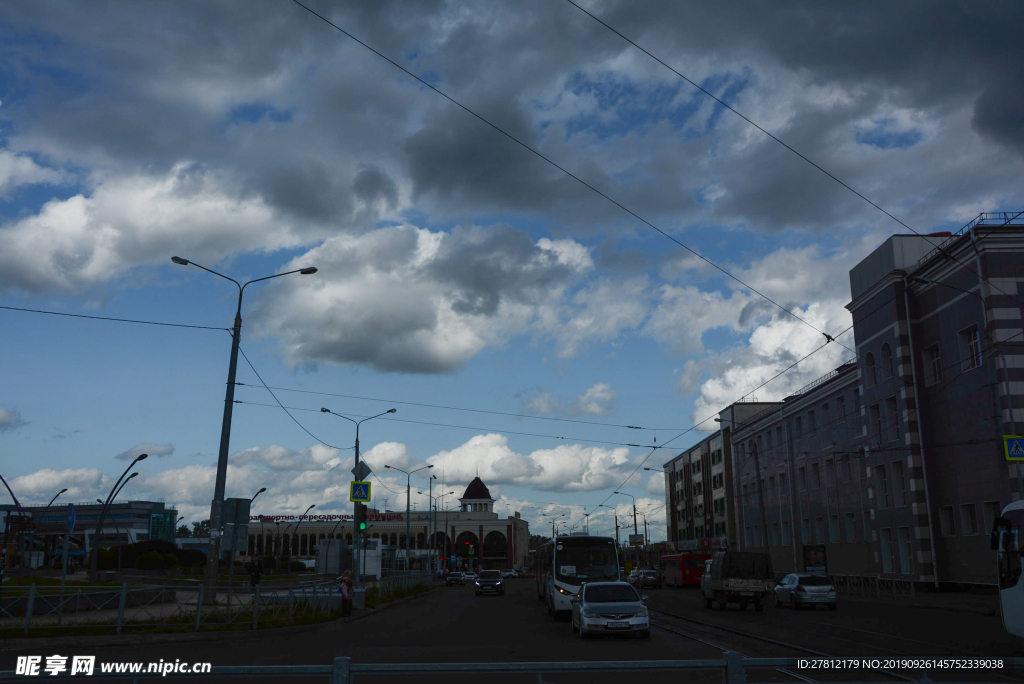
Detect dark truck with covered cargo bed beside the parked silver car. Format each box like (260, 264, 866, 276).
(700, 551, 775, 612)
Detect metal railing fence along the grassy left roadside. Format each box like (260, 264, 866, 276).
(0, 579, 340, 635)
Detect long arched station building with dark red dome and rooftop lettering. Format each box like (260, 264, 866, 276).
(240, 477, 529, 568)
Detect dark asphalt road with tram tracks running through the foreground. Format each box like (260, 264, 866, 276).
(0, 579, 1024, 684)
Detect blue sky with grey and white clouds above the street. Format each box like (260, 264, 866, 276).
(0, 0, 1024, 540)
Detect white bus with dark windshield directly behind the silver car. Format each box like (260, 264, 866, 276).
(537, 536, 622, 619)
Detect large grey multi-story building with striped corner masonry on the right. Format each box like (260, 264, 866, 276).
(696, 214, 1024, 585)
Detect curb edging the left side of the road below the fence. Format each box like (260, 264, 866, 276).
(0, 586, 435, 653)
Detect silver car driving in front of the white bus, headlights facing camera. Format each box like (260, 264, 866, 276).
(572, 582, 650, 639)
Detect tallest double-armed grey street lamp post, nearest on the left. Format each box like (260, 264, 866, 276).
(171, 256, 316, 602)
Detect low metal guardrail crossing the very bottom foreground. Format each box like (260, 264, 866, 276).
(0, 651, 1024, 684)
